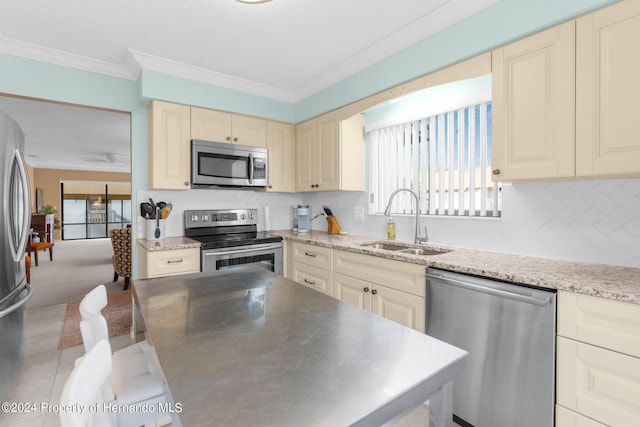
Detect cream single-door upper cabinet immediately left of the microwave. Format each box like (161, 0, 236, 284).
(149, 101, 191, 190)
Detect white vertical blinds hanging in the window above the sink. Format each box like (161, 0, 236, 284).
(368, 102, 501, 216)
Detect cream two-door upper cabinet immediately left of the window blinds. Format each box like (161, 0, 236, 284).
(296, 110, 365, 191)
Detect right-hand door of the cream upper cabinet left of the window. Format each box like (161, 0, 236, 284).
(314, 113, 341, 191)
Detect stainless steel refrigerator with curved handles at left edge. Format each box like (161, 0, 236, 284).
(0, 111, 33, 402)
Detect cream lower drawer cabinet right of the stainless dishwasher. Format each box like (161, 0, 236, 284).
(556, 292, 640, 427)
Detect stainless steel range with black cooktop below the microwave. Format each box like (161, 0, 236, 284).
(184, 209, 282, 275)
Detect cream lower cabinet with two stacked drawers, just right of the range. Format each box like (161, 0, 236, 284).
(291, 242, 333, 295)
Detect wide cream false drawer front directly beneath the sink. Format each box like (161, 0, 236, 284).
(333, 250, 426, 297)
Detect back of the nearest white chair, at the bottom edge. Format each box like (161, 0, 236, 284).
(59, 340, 114, 427)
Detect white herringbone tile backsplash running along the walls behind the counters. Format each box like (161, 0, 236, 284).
(137, 179, 640, 267)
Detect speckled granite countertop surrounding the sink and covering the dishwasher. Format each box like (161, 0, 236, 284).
(274, 230, 640, 304)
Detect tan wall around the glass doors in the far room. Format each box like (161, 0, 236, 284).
(30, 169, 131, 240)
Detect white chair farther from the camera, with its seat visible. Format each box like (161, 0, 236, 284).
(80, 285, 166, 426)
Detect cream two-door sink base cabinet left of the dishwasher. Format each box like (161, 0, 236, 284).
(332, 250, 426, 332)
